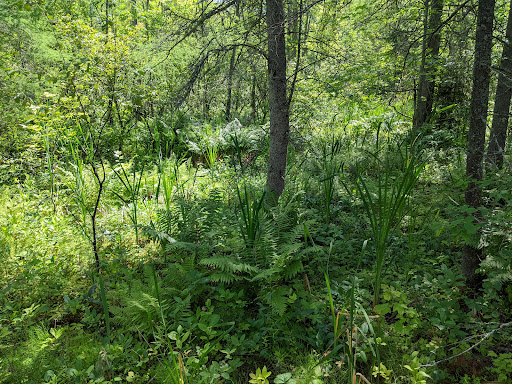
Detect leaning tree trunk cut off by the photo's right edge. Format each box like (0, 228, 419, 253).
(486, 0, 512, 170)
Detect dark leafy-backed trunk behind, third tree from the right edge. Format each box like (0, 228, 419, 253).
(413, 0, 443, 131)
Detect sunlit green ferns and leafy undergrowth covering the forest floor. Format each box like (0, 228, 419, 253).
(0, 112, 512, 383)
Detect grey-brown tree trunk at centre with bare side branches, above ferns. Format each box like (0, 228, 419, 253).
(266, 0, 290, 205)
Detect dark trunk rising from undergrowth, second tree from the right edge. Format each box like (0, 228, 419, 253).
(462, 0, 495, 290)
